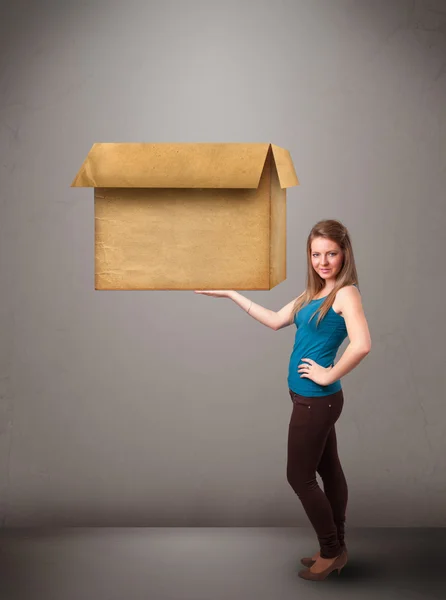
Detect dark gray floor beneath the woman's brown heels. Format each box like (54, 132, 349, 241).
(0, 527, 446, 600)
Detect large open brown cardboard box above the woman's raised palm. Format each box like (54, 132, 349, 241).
(71, 143, 299, 290)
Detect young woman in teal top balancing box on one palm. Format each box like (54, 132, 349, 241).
(195, 220, 371, 580)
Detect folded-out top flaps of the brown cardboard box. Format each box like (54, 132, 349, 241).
(71, 142, 298, 188)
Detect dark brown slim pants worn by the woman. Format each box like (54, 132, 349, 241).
(287, 390, 348, 558)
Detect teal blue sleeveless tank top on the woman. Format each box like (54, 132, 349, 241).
(288, 288, 358, 396)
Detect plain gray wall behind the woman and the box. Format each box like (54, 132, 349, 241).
(0, 0, 446, 526)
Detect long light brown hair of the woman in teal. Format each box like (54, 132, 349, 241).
(292, 219, 359, 327)
